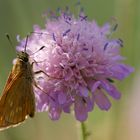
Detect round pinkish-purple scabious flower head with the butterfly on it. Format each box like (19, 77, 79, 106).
(17, 9, 133, 121)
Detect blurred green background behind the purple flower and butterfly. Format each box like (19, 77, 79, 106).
(0, 0, 140, 140)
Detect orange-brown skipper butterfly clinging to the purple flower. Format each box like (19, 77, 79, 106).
(0, 34, 35, 130)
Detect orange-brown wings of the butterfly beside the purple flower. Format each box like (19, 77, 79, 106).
(0, 71, 35, 130)
